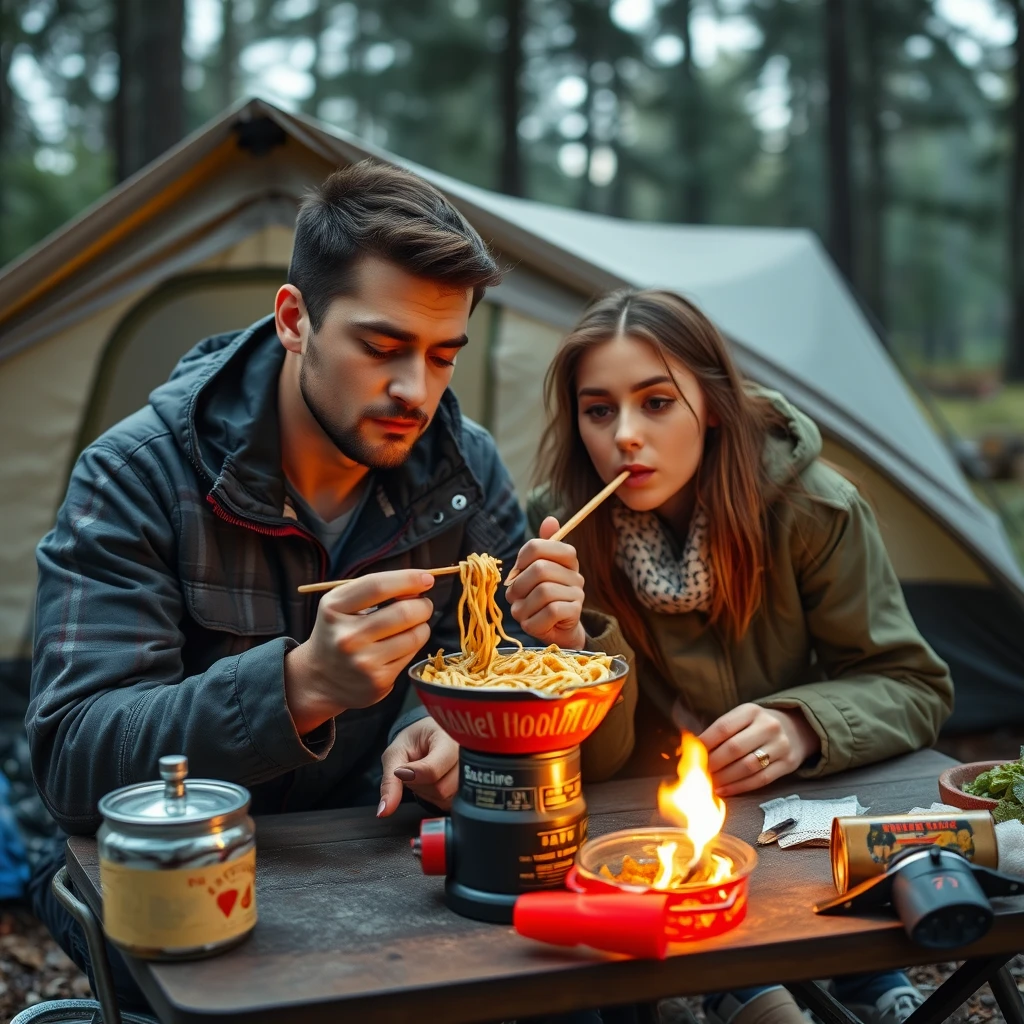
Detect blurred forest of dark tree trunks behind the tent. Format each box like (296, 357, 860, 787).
(0, 0, 1024, 554)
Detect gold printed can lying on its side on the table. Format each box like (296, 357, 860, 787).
(829, 811, 999, 896)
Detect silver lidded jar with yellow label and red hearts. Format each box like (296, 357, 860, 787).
(96, 755, 256, 961)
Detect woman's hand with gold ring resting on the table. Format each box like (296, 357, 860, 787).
(700, 703, 821, 797)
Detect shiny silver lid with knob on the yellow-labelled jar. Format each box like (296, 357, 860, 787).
(99, 754, 249, 828)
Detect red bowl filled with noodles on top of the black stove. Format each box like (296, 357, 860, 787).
(409, 647, 629, 754)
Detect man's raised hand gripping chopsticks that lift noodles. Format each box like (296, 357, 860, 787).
(285, 569, 434, 735)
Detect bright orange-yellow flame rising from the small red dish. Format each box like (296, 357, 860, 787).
(653, 732, 732, 889)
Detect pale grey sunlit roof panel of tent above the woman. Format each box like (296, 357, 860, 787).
(401, 177, 1024, 591)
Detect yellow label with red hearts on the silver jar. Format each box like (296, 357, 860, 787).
(99, 849, 256, 949)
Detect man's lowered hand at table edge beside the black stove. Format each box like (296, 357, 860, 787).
(377, 718, 459, 818)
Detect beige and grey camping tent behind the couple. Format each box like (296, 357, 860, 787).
(0, 100, 1024, 729)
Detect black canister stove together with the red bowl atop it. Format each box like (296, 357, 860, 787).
(410, 648, 629, 924)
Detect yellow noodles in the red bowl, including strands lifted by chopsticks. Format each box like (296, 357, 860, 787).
(423, 554, 611, 694)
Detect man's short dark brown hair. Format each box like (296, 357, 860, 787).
(288, 160, 501, 332)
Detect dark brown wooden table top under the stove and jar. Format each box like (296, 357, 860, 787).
(68, 751, 1024, 1024)
